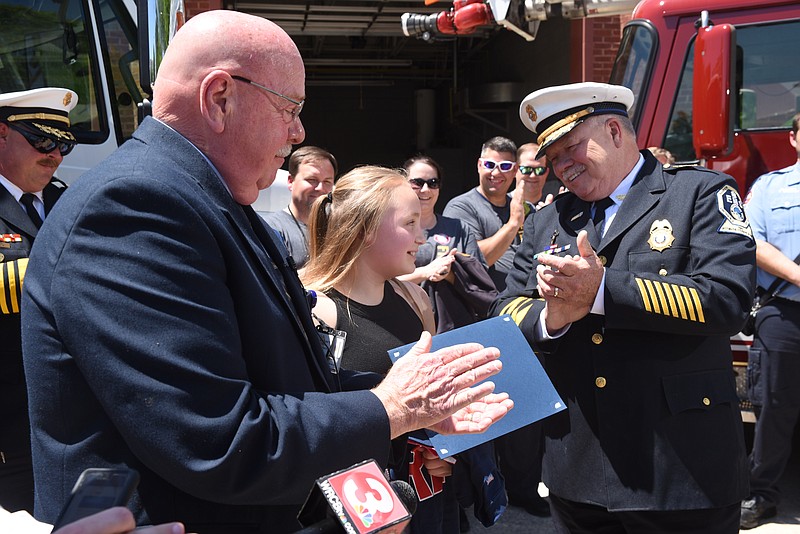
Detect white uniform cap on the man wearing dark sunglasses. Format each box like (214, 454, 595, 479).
(0, 87, 78, 143)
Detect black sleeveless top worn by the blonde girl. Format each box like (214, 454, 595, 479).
(328, 282, 422, 375)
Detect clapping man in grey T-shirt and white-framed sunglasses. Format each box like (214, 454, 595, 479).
(443, 137, 531, 291)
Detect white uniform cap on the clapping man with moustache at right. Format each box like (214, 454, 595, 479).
(519, 82, 633, 159)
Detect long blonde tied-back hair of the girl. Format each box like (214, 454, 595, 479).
(301, 165, 408, 293)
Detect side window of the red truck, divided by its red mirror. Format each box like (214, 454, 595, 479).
(663, 21, 800, 161)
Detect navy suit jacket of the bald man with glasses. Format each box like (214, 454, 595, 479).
(23, 118, 390, 533)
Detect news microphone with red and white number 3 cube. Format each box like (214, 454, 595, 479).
(297, 460, 417, 534)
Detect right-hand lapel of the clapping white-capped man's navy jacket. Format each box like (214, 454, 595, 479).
(597, 156, 666, 252)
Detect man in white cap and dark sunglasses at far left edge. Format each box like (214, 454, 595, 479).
(0, 88, 78, 513)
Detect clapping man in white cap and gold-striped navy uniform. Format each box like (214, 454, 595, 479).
(494, 83, 755, 533)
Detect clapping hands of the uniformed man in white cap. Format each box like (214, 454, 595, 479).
(536, 230, 603, 334)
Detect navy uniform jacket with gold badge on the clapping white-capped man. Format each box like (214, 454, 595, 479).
(494, 151, 755, 511)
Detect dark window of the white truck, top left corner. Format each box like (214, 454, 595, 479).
(0, 0, 108, 143)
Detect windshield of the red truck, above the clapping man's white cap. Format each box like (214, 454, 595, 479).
(610, 23, 656, 129)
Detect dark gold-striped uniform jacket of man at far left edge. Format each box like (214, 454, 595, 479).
(0, 178, 67, 462)
